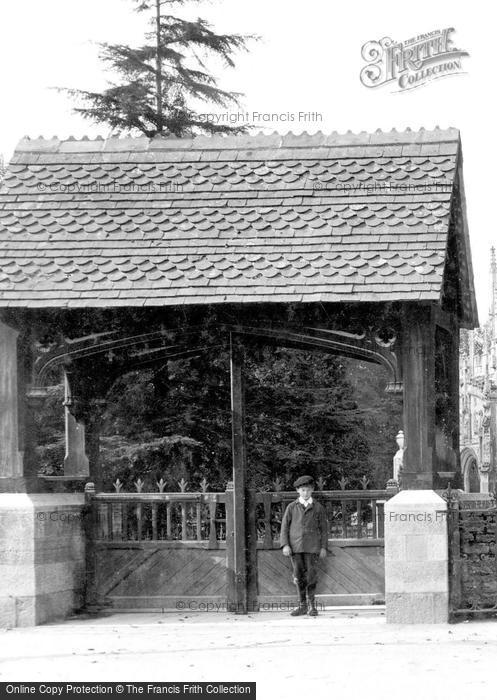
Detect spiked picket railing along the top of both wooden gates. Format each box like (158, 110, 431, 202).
(85, 484, 393, 549)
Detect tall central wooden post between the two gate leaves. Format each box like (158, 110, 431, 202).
(230, 333, 247, 614)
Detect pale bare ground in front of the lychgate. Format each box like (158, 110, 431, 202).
(0, 609, 497, 700)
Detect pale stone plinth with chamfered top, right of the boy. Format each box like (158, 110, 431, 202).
(385, 490, 449, 623)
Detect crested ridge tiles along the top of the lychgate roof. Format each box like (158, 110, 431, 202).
(15, 126, 459, 153)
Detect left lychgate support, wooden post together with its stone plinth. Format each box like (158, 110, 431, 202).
(0, 321, 85, 628)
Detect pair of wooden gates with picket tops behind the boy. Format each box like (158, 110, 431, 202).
(86, 484, 391, 611)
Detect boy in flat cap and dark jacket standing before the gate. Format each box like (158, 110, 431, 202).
(280, 475, 328, 617)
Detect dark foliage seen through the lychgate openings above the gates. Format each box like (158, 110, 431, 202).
(34, 347, 400, 490)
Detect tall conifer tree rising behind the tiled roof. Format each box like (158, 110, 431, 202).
(62, 0, 256, 137)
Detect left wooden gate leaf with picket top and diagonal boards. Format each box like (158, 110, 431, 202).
(87, 492, 232, 610)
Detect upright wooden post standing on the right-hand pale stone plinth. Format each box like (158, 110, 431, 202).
(402, 306, 435, 489)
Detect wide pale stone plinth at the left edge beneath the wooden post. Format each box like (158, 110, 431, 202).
(0, 493, 85, 627)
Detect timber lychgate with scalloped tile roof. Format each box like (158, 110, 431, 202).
(0, 129, 477, 625)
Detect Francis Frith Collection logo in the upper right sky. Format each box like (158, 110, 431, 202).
(360, 27, 469, 92)
